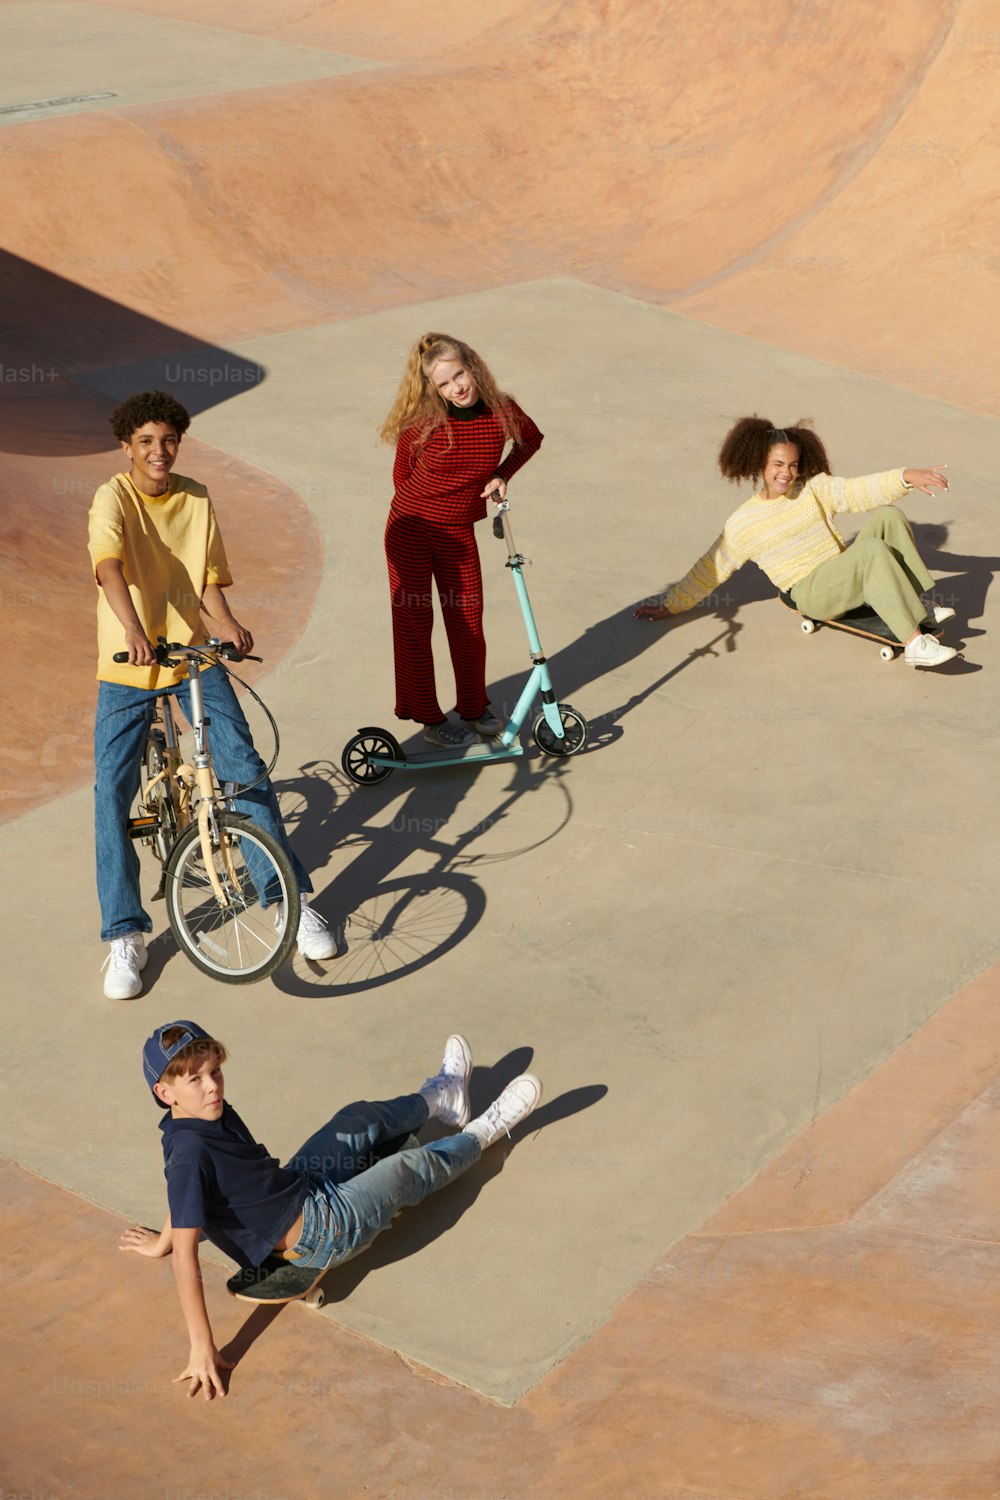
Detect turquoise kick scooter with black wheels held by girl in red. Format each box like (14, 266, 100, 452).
(340, 500, 588, 786)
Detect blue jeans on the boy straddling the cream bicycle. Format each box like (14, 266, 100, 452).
(94, 666, 312, 942)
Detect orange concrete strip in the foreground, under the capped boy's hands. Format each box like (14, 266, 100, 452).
(7, 971, 1000, 1500)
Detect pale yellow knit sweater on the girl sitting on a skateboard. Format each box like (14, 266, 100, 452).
(663, 470, 910, 615)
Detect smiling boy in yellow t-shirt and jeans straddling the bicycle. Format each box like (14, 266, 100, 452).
(88, 390, 337, 1001)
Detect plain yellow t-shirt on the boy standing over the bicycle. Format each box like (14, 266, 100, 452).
(87, 474, 232, 689)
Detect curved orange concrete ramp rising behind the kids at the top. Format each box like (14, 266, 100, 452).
(0, 0, 1000, 411)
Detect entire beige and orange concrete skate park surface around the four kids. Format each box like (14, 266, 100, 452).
(0, 0, 1000, 1500)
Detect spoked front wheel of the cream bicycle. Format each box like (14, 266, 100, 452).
(166, 813, 300, 984)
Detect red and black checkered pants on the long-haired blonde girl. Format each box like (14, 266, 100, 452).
(385, 510, 489, 725)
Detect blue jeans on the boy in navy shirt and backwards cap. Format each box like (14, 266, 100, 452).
(285, 1094, 483, 1266)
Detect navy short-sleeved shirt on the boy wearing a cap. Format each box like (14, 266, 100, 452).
(160, 1104, 306, 1266)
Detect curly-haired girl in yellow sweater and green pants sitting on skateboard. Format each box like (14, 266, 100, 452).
(636, 417, 957, 666)
